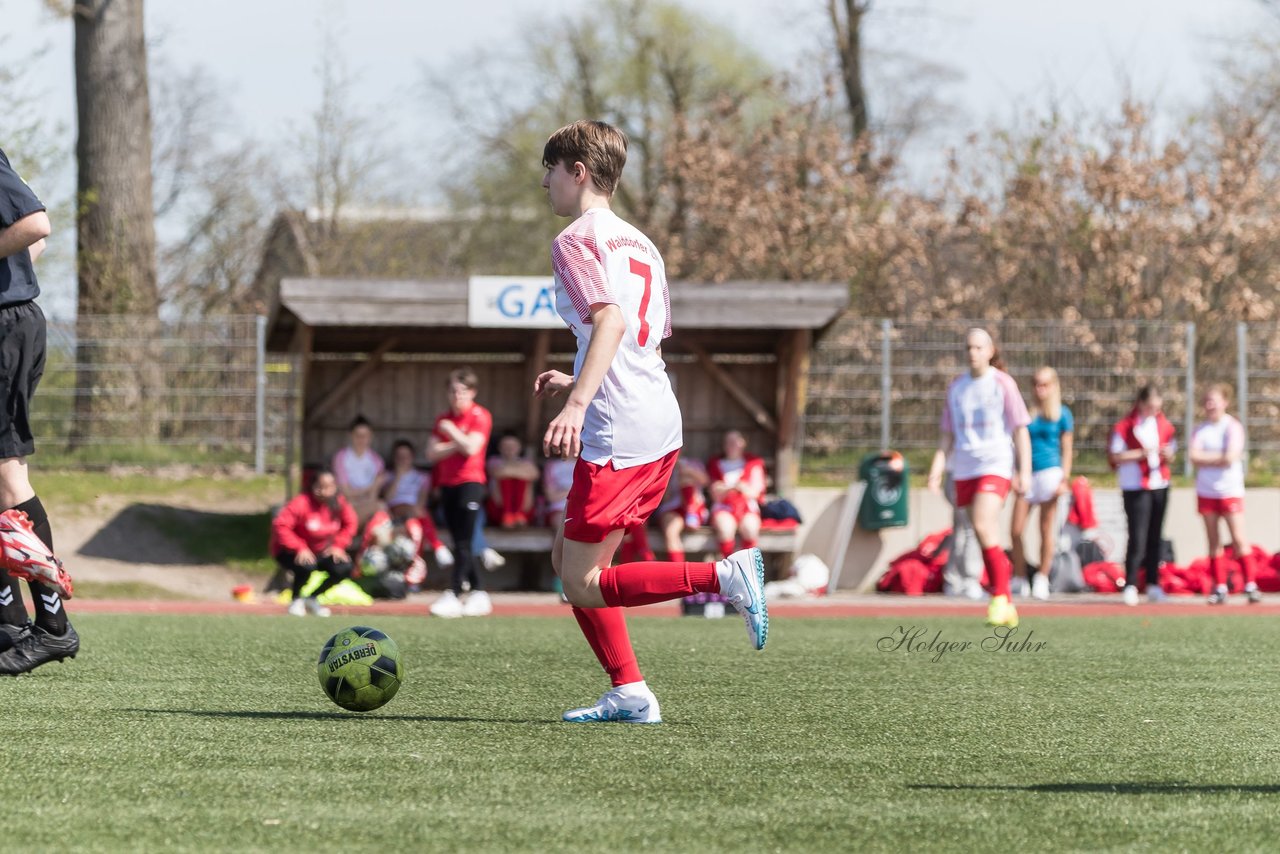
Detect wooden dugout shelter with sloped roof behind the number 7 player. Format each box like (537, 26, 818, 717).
(268, 277, 849, 494)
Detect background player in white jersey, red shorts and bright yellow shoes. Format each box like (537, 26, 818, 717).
(929, 329, 1032, 629)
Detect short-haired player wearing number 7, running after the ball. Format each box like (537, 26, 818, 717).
(534, 122, 769, 723)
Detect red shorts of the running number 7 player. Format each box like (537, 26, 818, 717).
(564, 449, 680, 543)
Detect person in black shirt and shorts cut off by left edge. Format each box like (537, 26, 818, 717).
(0, 151, 79, 676)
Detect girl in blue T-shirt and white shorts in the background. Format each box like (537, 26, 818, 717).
(1011, 367, 1075, 599)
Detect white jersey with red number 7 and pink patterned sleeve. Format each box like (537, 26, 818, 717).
(552, 209, 682, 469)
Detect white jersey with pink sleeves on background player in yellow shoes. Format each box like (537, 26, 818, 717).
(942, 367, 1030, 480)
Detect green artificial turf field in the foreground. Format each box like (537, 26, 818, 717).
(0, 613, 1280, 853)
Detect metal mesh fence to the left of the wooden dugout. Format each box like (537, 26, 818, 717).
(32, 316, 297, 472)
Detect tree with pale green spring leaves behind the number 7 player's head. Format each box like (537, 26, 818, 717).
(429, 0, 781, 273)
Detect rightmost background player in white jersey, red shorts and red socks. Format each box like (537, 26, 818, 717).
(1189, 385, 1262, 604)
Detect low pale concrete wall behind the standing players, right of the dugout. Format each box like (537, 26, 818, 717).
(794, 488, 1280, 589)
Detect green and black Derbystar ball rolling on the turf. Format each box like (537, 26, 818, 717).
(319, 626, 404, 712)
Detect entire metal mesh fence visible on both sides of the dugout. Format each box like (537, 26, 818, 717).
(32, 316, 1280, 478)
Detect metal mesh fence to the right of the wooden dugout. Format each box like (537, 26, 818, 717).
(804, 319, 1213, 478)
